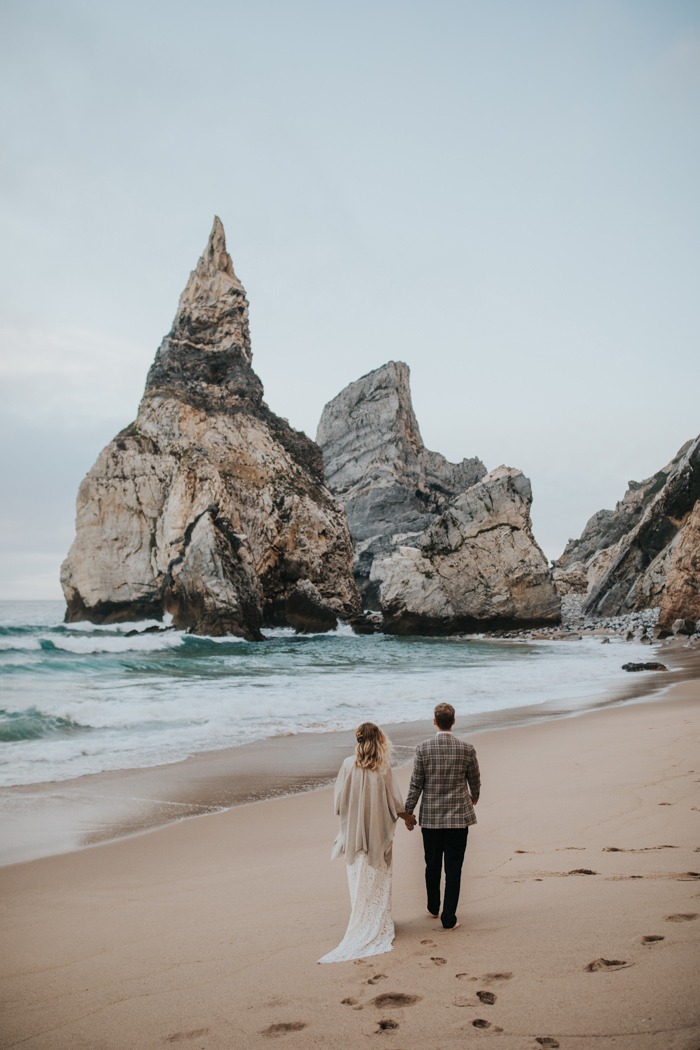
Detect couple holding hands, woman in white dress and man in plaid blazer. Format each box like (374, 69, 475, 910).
(319, 704, 481, 963)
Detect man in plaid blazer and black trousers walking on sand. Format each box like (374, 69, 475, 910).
(405, 704, 481, 929)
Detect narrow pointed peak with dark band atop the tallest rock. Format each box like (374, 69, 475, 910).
(146, 215, 262, 404)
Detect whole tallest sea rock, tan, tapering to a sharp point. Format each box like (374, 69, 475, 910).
(61, 218, 360, 639)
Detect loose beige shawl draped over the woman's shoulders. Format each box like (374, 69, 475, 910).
(331, 755, 403, 867)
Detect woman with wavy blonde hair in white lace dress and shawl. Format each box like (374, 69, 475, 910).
(319, 722, 412, 963)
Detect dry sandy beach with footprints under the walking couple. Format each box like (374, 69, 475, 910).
(0, 651, 700, 1050)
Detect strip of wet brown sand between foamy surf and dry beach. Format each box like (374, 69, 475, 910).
(0, 642, 700, 868)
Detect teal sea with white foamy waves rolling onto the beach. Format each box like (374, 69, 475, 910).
(0, 601, 650, 786)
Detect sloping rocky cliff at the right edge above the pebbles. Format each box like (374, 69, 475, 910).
(555, 437, 700, 629)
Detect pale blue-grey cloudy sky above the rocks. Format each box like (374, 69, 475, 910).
(0, 0, 700, 599)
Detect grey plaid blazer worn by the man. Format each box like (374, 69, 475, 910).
(406, 732, 481, 827)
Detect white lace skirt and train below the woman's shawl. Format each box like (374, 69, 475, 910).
(319, 853, 394, 963)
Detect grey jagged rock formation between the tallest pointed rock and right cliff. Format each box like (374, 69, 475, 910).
(317, 361, 559, 634)
